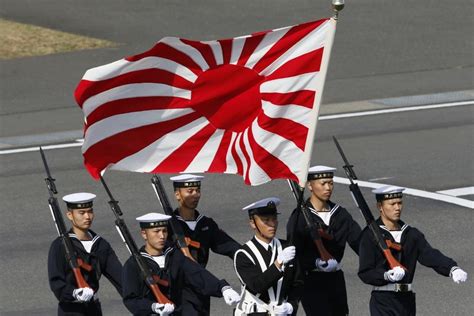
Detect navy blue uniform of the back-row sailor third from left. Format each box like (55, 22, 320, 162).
(169, 209, 240, 315)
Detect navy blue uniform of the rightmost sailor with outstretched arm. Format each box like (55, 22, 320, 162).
(359, 218, 457, 315)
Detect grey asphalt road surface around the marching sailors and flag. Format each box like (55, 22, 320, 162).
(0, 0, 474, 315)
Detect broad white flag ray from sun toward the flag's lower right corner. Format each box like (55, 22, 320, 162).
(252, 120, 306, 178)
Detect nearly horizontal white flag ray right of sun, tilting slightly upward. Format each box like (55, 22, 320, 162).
(260, 72, 319, 93)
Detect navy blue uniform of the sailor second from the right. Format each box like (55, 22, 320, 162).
(286, 199, 361, 316)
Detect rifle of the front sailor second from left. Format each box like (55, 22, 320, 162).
(100, 176, 173, 304)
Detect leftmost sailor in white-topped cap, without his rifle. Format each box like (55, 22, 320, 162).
(48, 193, 122, 315)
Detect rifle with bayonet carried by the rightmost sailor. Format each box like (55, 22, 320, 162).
(332, 136, 406, 270)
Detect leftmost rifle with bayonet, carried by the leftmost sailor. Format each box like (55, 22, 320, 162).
(40, 147, 92, 288)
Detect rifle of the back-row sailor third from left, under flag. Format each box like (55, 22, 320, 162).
(151, 174, 201, 262)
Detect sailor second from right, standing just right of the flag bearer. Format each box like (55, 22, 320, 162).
(287, 165, 361, 316)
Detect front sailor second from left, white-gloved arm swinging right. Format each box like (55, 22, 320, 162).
(122, 213, 240, 316)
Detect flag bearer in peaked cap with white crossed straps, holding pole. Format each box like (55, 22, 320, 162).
(234, 198, 302, 315)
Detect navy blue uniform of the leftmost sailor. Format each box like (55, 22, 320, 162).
(48, 230, 122, 315)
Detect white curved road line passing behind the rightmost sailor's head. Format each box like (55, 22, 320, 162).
(333, 177, 474, 209)
